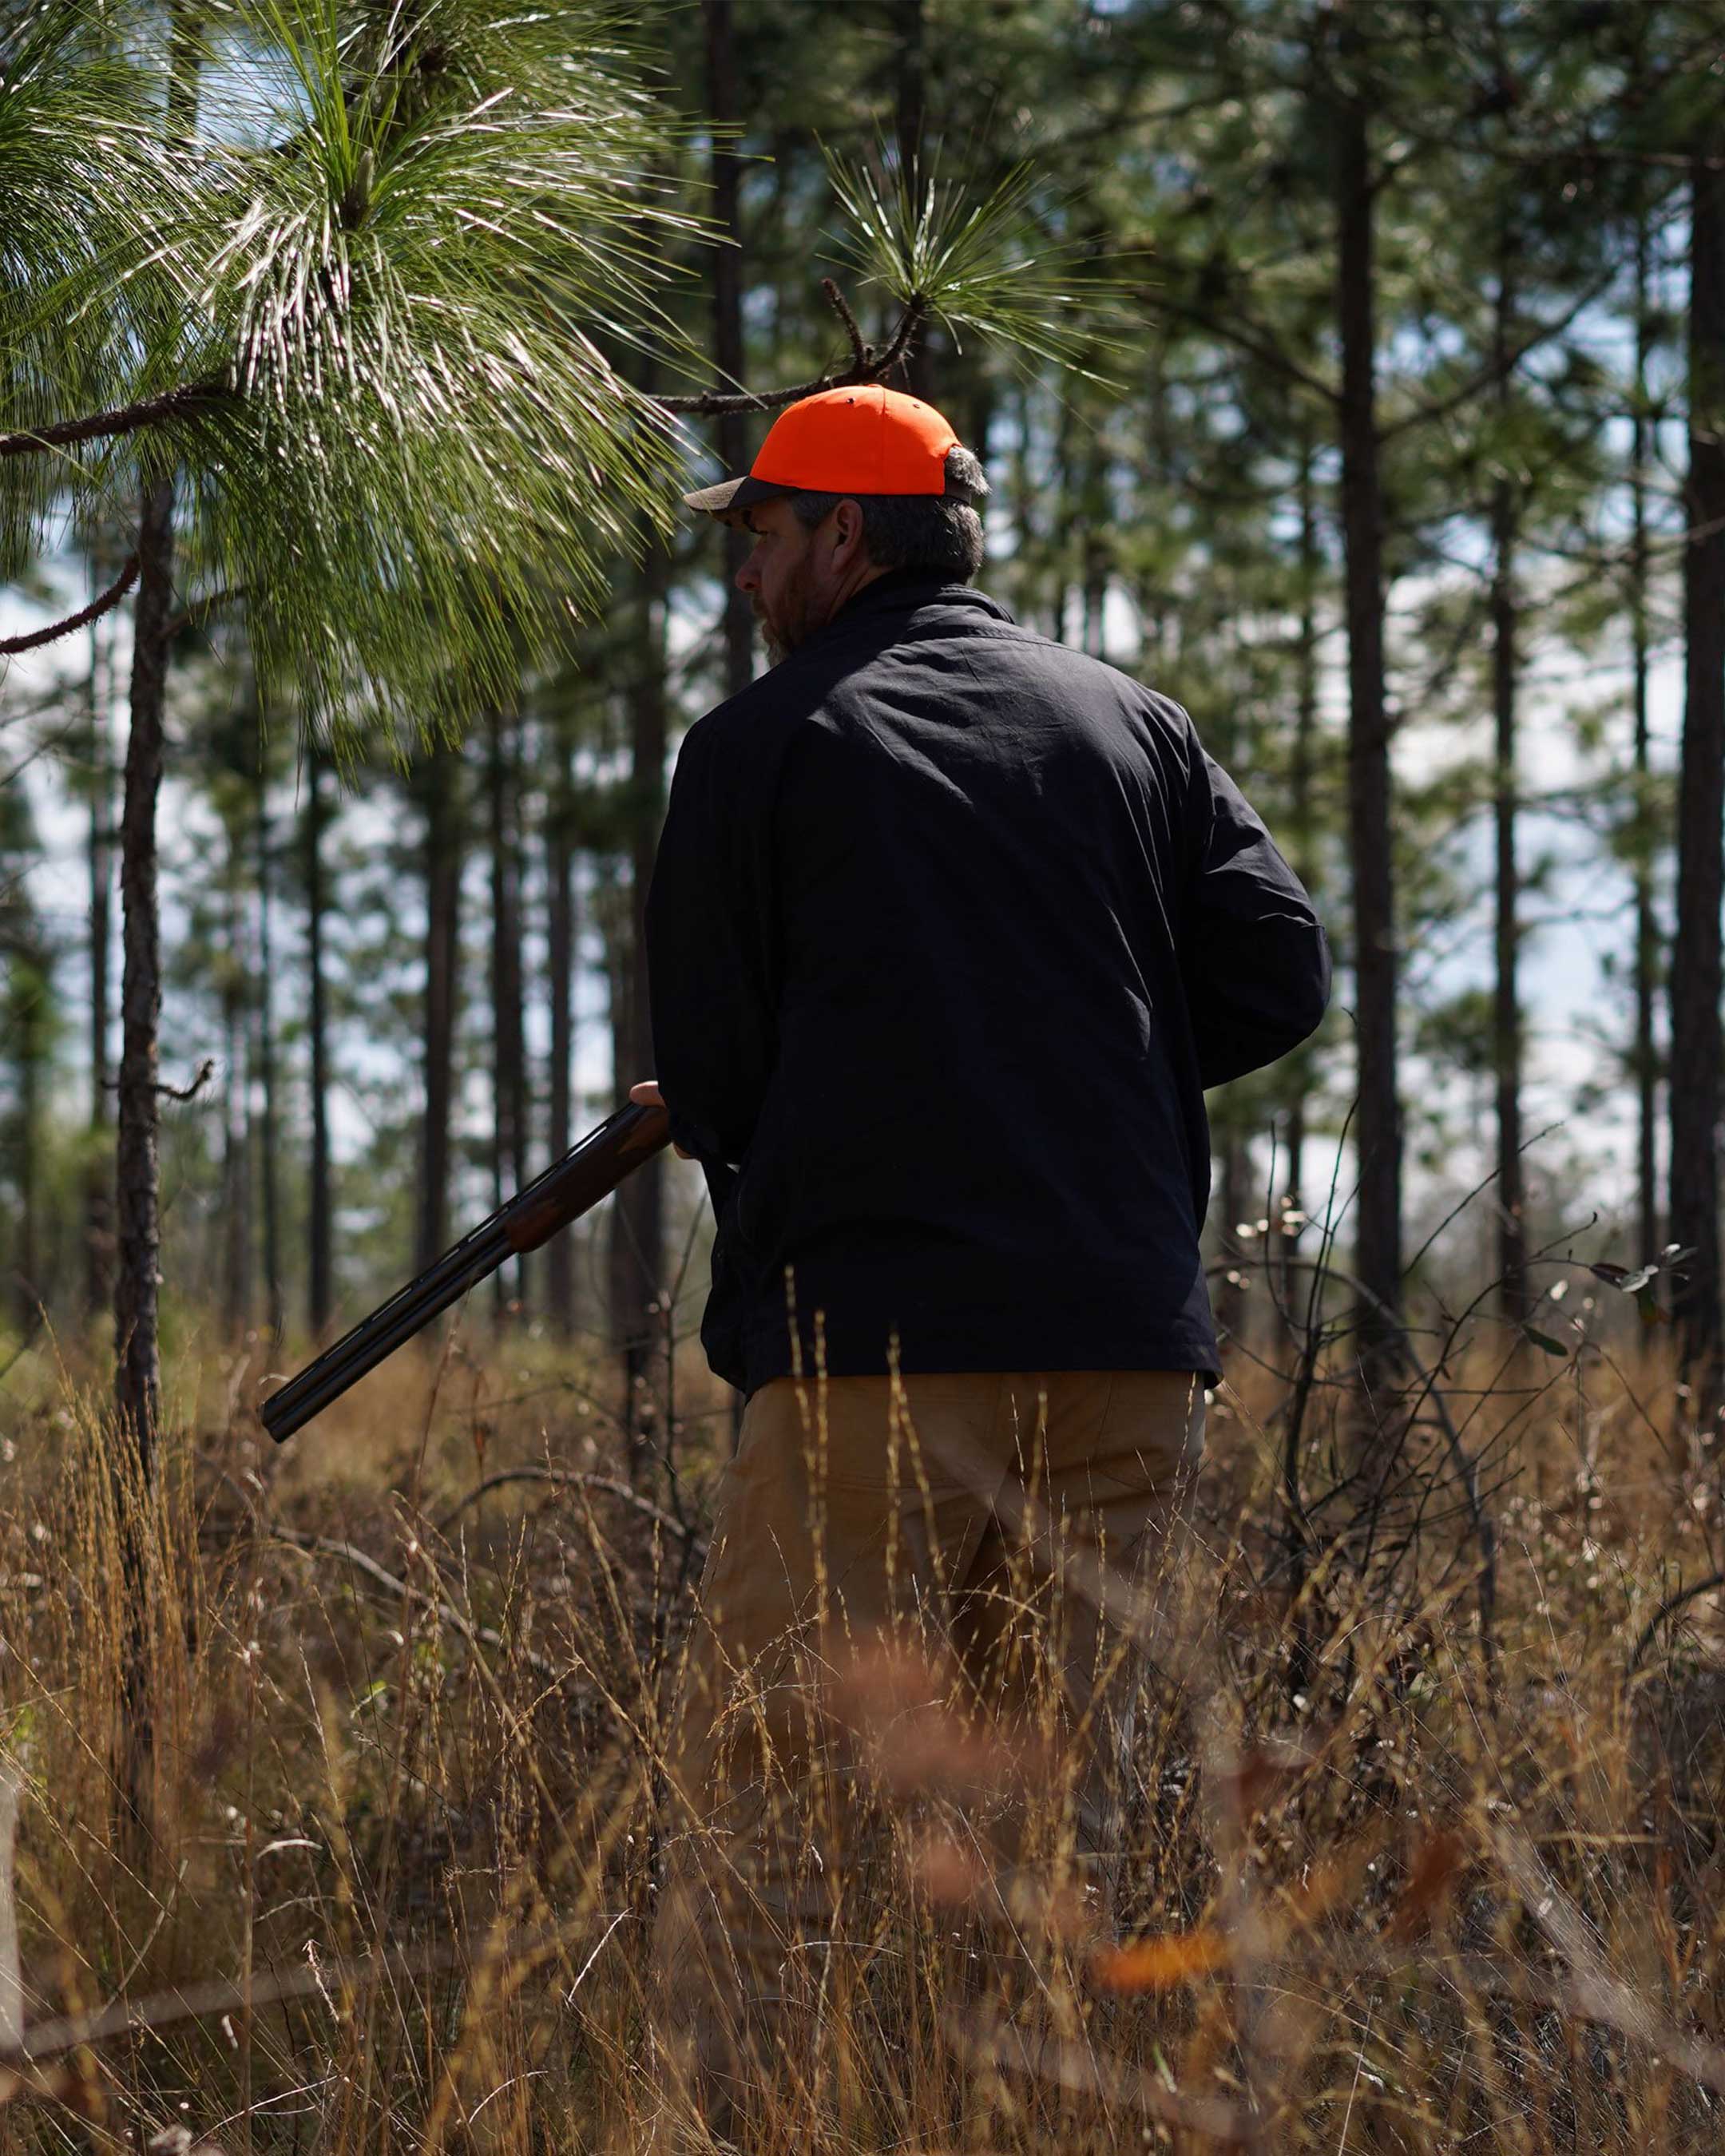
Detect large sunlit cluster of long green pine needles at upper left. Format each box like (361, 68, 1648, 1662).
(0, 0, 694, 731)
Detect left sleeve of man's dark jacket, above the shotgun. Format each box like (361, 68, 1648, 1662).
(647, 720, 779, 1197)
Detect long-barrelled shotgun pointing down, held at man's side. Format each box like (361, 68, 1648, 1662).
(261, 1102, 671, 1445)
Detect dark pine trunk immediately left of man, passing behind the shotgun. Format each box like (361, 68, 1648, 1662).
(610, 545, 668, 1475)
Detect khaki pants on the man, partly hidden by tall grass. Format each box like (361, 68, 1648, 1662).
(653, 1371, 1204, 2113)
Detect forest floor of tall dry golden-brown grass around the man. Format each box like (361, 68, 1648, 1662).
(0, 1341, 1725, 2156)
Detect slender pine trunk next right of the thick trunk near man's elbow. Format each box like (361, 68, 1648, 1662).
(1490, 240, 1527, 1324)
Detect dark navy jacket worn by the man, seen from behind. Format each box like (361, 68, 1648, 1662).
(647, 572, 1330, 1391)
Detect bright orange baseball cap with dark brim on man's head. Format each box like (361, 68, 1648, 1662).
(684, 382, 958, 517)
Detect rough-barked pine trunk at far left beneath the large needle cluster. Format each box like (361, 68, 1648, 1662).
(114, 477, 175, 1488)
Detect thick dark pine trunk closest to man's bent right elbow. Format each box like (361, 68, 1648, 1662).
(1330, 95, 1402, 1371)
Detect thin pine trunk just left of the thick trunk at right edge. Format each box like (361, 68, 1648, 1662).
(1630, 218, 1660, 1266)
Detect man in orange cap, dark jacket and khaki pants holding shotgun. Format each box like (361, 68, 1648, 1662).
(636, 386, 1328, 2121)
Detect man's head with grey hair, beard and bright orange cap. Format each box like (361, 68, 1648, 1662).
(686, 386, 988, 660)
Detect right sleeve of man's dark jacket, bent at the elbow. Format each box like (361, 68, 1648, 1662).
(1180, 739, 1330, 1087)
